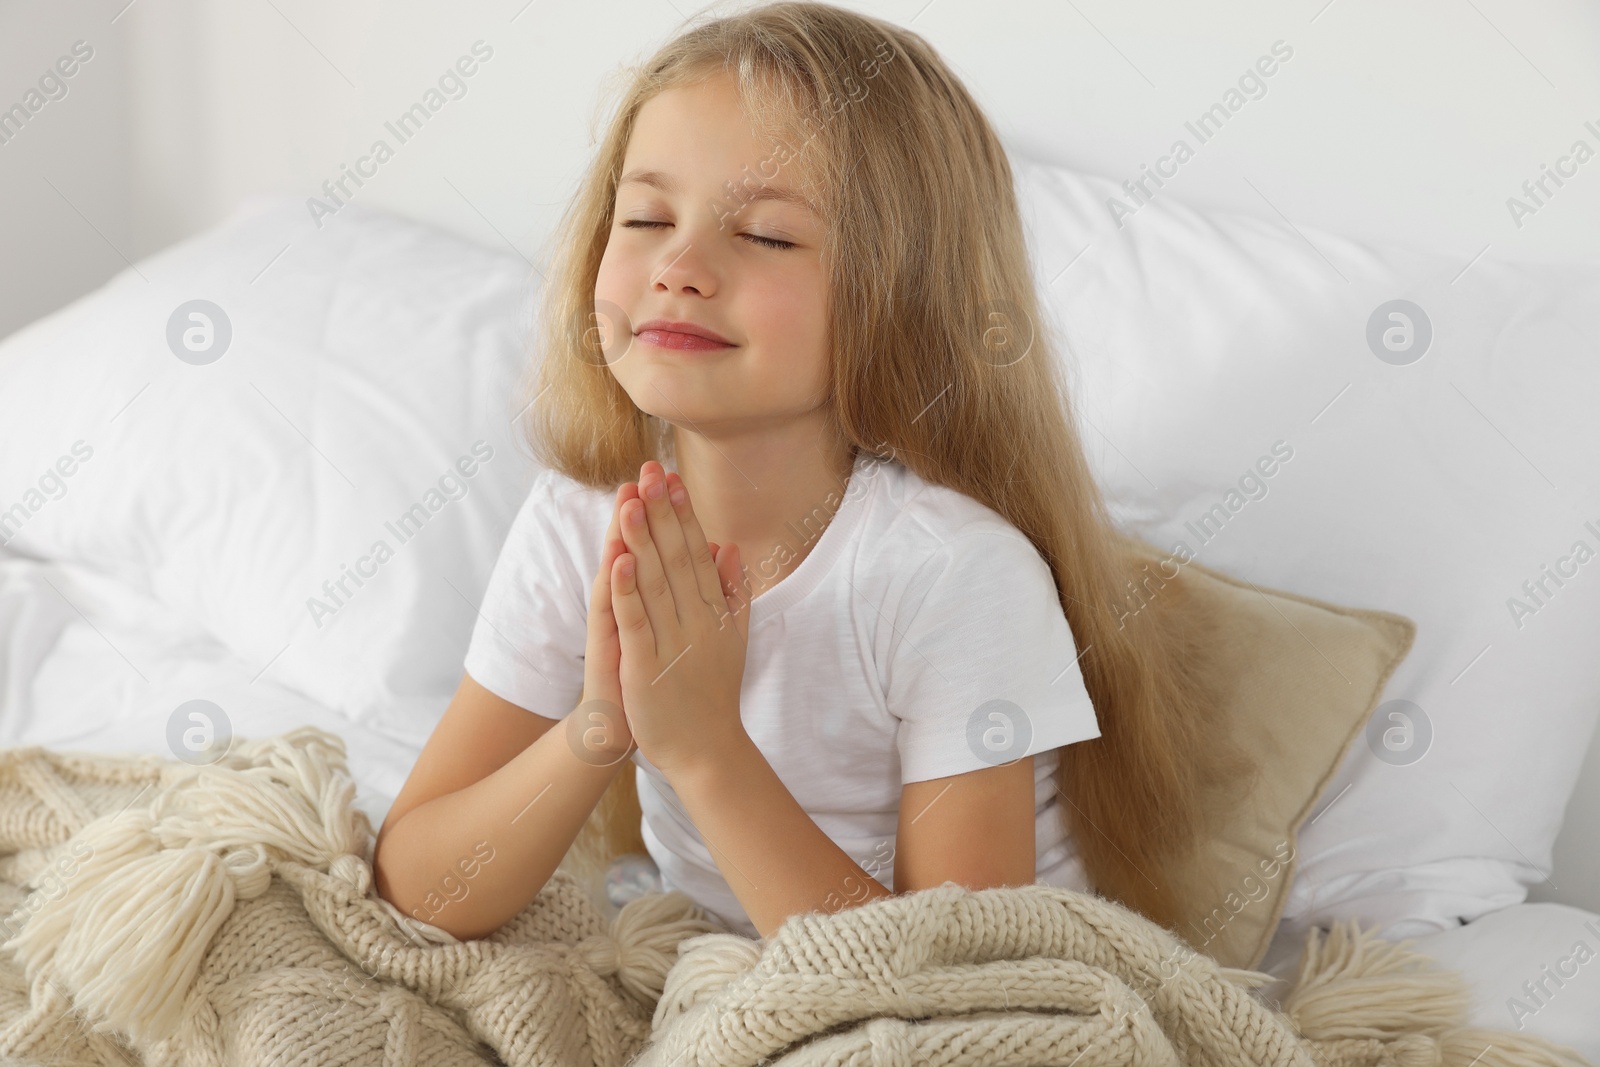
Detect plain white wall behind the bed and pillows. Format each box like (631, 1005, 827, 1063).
(0, 0, 1600, 907)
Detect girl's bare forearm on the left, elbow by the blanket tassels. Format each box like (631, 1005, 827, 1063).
(373, 721, 632, 939)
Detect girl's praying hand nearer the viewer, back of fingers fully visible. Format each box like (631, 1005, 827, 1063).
(611, 459, 750, 777)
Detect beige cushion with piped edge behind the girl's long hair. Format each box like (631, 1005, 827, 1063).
(1152, 550, 1416, 968)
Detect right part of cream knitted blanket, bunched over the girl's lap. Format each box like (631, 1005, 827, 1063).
(635, 883, 1592, 1067)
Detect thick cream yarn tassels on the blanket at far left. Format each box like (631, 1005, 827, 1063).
(5, 726, 371, 1043)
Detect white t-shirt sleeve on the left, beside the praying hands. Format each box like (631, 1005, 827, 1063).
(464, 470, 589, 718)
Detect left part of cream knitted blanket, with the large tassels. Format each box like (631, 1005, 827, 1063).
(0, 728, 720, 1067)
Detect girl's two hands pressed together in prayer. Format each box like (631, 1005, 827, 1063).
(574, 459, 750, 777)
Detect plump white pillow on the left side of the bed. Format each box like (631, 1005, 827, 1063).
(0, 197, 538, 744)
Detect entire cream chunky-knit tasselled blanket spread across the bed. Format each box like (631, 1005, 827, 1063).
(0, 728, 1584, 1067)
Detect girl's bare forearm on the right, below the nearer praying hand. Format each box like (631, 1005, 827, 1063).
(670, 739, 893, 937)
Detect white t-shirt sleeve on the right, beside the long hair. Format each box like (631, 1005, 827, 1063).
(886, 528, 1099, 784)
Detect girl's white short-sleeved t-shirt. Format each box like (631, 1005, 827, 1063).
(466, 453, 1099, 937)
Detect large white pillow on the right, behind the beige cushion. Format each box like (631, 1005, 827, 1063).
(1013, 154, 1600, 936)
